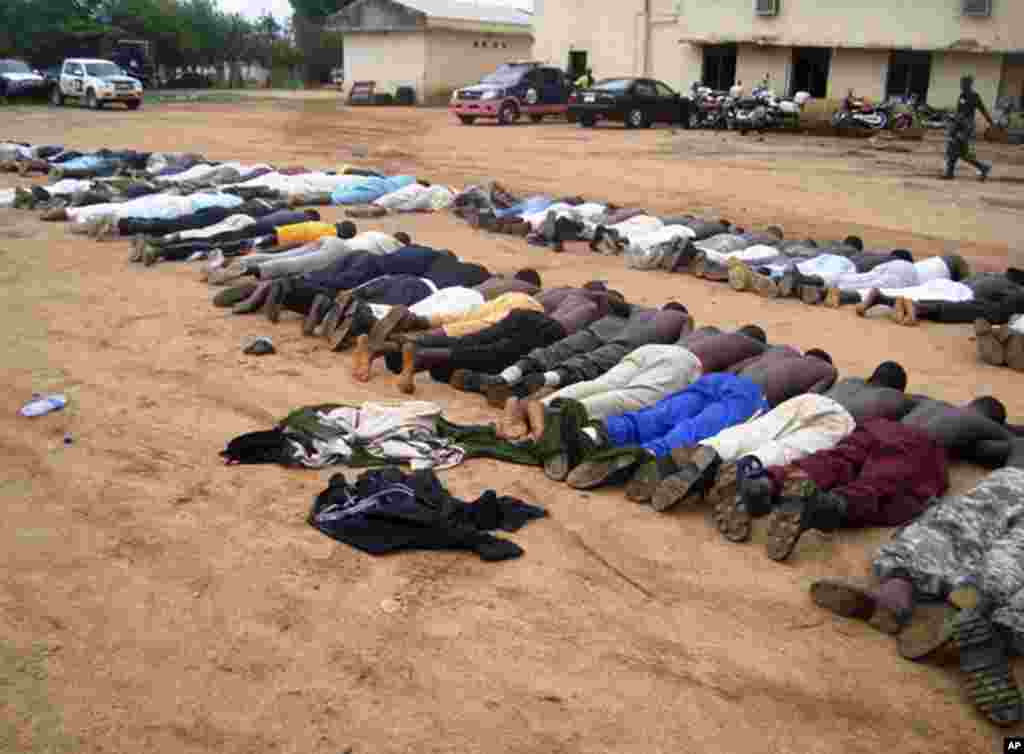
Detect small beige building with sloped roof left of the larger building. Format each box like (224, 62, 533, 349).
(328, 0, 534, 104)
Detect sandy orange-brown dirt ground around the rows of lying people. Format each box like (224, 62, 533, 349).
(0, 102, 1024, 754)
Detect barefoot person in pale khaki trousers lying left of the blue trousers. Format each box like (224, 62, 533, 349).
(495, 325, 767, 439)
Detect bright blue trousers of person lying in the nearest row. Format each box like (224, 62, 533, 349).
(605, 374, 768, 456)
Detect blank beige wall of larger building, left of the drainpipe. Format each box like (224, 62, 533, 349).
(534, 0, 643, 76)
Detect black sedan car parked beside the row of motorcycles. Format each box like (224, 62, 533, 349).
(569, 78, 693, 128)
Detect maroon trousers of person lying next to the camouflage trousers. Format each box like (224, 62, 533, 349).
(768, 419, 949, 528)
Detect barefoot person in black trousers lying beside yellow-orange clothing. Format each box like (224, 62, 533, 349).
(353, 284, 627, 392)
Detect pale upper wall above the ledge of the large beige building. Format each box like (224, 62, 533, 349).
(671, 0, 1024, 51)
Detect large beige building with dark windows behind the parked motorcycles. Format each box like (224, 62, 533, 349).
(534, 0, 1024, 107)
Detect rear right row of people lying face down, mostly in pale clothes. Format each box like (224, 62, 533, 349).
(455, 195, 1024, 325)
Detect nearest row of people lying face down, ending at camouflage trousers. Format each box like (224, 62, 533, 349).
(192, 231, 1024, 724)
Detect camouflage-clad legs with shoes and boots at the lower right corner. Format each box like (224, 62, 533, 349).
(811, 439, 1024, 726)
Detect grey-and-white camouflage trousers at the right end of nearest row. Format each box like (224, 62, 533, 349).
(873, 468, 1024, 638)
